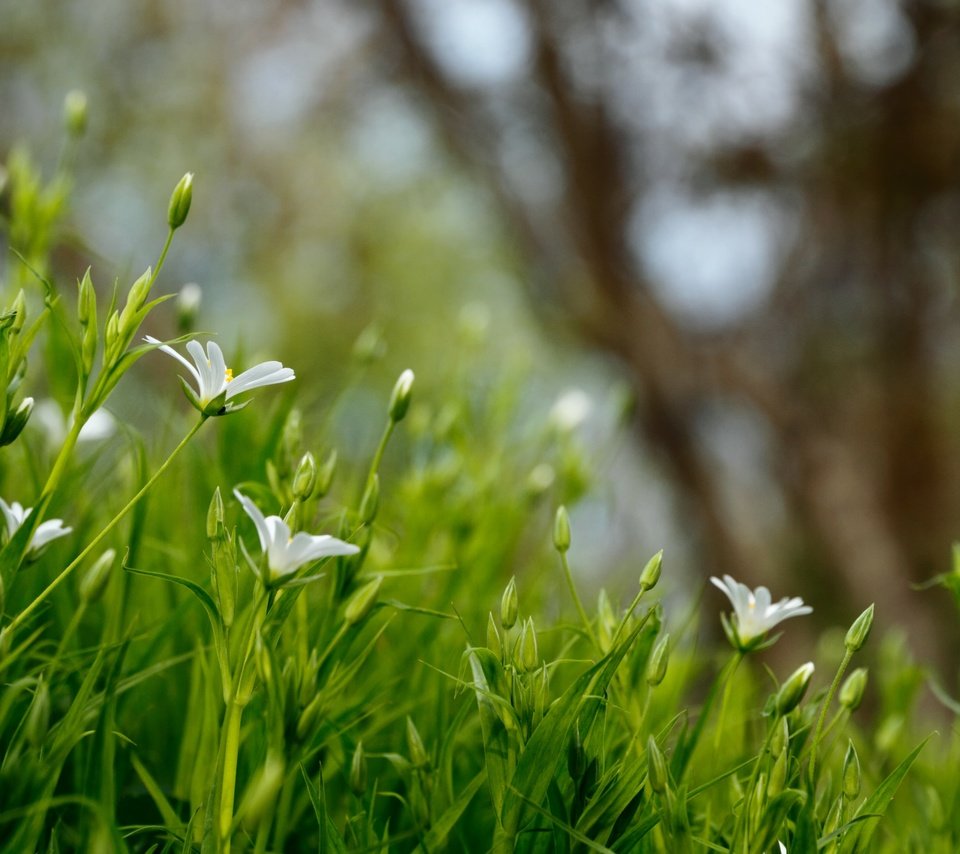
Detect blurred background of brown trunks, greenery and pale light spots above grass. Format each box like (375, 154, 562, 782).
(0, 0, 960, 666)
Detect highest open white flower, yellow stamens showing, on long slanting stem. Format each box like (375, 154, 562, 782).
(144, 335, 295, 415)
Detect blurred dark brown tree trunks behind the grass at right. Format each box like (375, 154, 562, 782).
(381, 0, 960, 664)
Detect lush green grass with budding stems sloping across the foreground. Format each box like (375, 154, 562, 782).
(0, 112, 960, 854)
